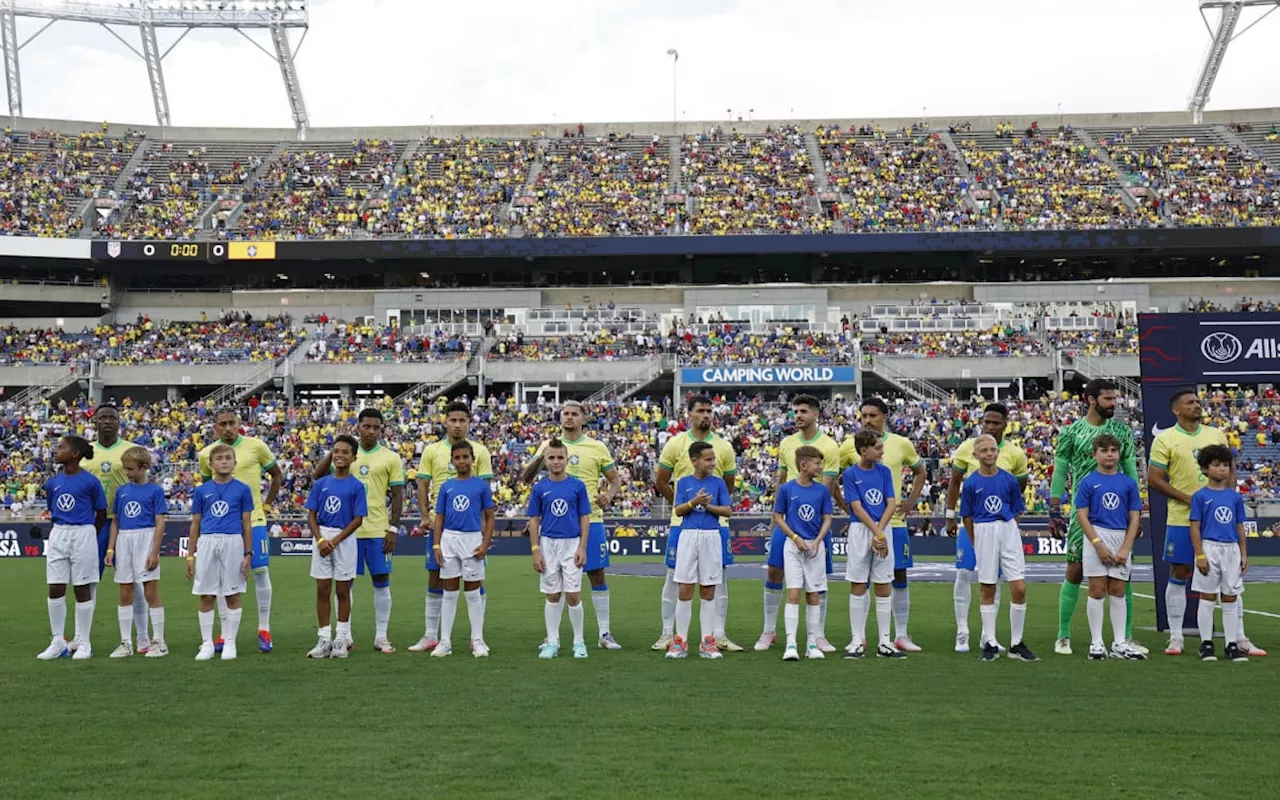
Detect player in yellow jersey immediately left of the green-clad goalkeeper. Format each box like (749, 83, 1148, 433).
(946, 403, 1030, 653)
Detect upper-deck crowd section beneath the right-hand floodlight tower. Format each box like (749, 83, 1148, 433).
(1098, 125, 1280, 227)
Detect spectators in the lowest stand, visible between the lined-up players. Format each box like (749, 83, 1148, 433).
(0, 390, 1280, 518)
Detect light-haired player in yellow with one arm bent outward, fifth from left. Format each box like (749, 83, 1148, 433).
(520, 401, 622, 650)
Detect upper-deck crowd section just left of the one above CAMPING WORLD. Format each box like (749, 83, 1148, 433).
(524, 136, 678, 236)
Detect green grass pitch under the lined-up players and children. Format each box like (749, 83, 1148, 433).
(0, 557, 1280, 797)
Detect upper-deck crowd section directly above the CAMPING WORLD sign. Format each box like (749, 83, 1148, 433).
(681, 125, 831, 234)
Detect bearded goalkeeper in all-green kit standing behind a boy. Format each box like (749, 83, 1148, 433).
(1048, 378, 1147, 655)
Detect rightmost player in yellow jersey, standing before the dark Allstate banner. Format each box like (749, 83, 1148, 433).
(1147, 389, 1266, 657)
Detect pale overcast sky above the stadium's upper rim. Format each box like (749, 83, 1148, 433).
(18, 0, 1280, 127)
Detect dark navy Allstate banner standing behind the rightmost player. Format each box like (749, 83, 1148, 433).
(1138, 312, 1280, 631)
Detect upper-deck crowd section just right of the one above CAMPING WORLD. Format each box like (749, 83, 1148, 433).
(815, 125, 982, 233)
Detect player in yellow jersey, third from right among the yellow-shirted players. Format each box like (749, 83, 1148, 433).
(836, 397, 927, 653)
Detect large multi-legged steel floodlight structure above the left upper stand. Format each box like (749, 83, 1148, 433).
(0, 0, 309, 140)
